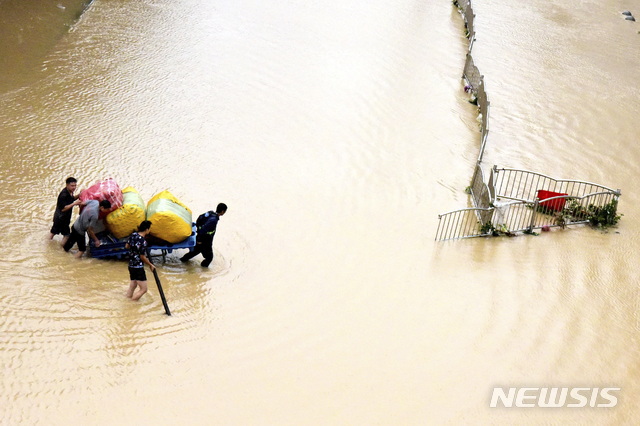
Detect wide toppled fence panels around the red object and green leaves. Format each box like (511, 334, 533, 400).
(436, 165, 620, 241)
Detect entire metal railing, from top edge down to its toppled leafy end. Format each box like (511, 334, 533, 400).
(436, 0, 620, 241)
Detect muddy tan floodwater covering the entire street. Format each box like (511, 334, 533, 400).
(0, 0, 640, 426)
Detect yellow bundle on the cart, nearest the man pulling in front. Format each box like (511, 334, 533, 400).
(147, 191, 191, 243)
